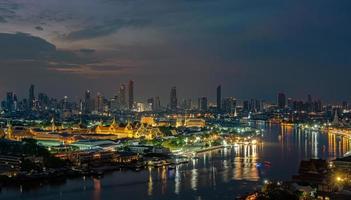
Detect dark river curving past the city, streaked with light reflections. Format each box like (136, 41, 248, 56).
(0, 123, 350, 200)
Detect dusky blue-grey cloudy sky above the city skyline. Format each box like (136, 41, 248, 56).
(0, 0, 351, 102)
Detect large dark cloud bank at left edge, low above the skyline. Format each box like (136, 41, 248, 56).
(0, 33, 133, 77)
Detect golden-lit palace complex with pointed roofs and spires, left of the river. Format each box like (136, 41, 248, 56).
(0, 119, 164, 144)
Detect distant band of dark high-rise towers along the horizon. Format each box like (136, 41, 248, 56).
(0, 80, 348, 106)
